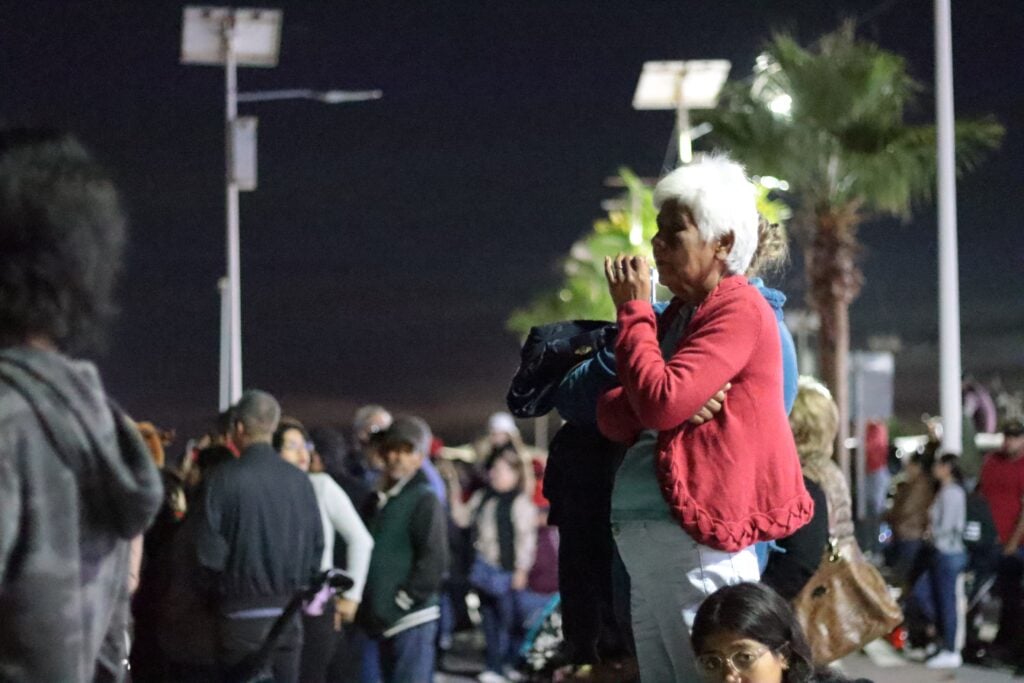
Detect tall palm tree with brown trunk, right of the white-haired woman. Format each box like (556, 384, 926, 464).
(700, 24, 1002, 475)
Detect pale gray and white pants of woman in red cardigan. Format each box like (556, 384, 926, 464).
(612, 519, 761, 683)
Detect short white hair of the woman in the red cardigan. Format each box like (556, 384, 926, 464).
(654, 156, 758, 274)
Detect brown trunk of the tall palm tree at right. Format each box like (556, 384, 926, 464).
(805, 203, 863, 481)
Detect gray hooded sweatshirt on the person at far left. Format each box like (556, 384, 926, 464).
(0, 347, 163, 682)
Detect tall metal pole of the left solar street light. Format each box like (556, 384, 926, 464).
(224, 16, 242, 403)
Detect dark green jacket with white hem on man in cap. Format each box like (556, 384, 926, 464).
(359, 470, 447, 637)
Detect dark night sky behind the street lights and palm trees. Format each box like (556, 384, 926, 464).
(0, 0, 1024, 440)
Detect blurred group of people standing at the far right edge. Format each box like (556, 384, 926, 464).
(882, 413, 1024, 669)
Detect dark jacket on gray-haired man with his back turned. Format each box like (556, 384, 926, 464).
(197, 443, 324, 614)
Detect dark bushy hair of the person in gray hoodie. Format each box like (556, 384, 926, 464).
(0, 128, 126, 352)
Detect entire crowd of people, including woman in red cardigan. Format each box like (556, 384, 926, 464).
(0, 129, 1024, 683)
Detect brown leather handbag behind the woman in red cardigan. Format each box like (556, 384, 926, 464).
(793, 539, 903, 666)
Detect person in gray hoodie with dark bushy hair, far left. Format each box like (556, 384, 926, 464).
(0, 129, 163, 683)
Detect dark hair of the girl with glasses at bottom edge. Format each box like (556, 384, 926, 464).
(690, 584, 814, 683)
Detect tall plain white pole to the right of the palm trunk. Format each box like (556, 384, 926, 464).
(935, 0, 964, 454)
